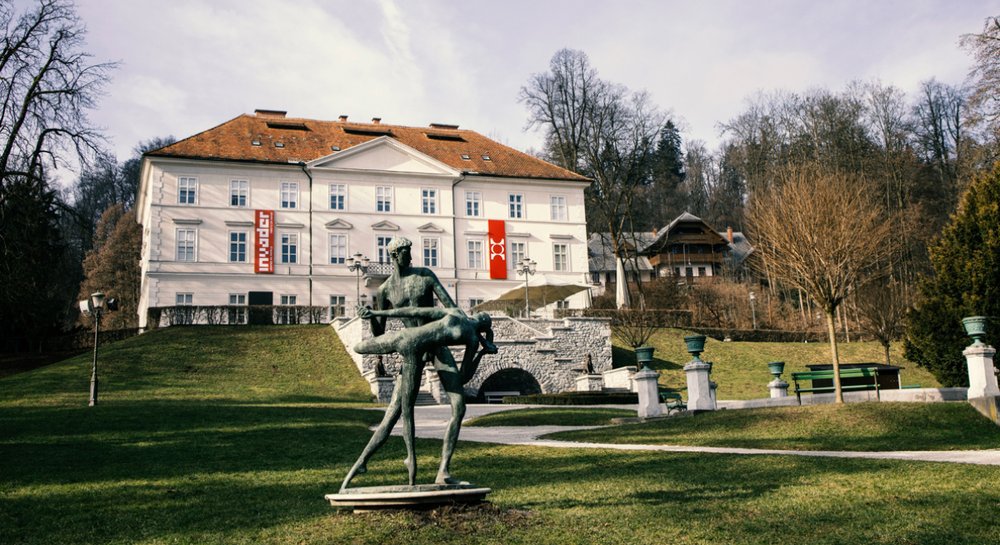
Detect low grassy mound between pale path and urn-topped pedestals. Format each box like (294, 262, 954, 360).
(552, 402, 1000, 451)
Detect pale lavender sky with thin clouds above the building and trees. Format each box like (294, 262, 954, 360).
(64, 0, 1000, 166)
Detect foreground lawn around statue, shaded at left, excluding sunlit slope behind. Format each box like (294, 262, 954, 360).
(0, 401, 1000, 544)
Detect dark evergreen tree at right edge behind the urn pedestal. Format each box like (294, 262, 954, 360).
(905, 159, 1000, 386)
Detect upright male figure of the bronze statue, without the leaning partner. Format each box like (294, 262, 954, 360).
(341, 237, 478, 490)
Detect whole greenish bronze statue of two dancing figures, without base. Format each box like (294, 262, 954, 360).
(341, 237, 496, 491)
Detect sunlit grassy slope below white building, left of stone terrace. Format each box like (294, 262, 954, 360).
(0, 326, 370, 405)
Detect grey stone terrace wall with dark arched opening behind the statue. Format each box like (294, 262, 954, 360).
(332, 316, 611, 401)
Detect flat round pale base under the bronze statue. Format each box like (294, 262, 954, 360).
(324, 484, 491, 513)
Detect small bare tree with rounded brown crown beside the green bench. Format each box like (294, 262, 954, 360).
(748, 165, 894, 403)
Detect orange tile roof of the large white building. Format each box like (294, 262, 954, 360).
(146, 114, 590, 182)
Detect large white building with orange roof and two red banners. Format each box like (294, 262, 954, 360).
(137, 110, 589, 327)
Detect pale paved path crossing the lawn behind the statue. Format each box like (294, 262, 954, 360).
(393, 405, 1000, 465)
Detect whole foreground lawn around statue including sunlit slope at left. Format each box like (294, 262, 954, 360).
(0, 326, 1000, 545)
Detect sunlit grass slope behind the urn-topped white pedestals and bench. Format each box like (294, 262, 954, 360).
(614, 329, 940, 399)
